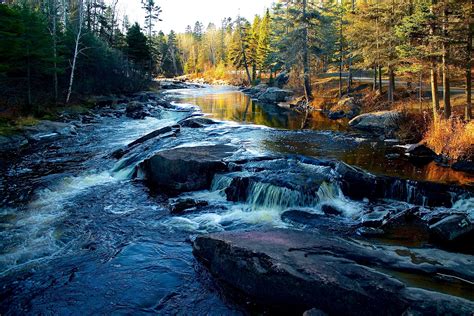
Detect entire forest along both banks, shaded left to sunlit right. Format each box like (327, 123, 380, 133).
(0, 0, 473, 160)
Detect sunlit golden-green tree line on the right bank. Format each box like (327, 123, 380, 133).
(178, 0, 474, 120)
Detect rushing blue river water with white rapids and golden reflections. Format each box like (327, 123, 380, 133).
(0, 87, 473, 315)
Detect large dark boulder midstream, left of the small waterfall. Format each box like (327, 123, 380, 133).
(140, 145, 237, 192)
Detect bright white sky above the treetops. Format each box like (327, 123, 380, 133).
(115, 0, 273, 33)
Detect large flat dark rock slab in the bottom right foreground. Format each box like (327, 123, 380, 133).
(194, 230, 474, 315)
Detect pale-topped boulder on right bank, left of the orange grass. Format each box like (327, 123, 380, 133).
(349, 111, 402, 137)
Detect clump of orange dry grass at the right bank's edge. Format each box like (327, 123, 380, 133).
(425, 118, 474, 160)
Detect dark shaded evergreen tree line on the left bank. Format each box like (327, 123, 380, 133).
(0, 0, 169, 113)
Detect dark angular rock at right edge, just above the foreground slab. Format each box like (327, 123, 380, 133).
(429, 215, 474, 241)
